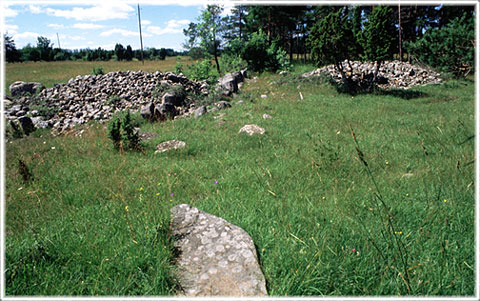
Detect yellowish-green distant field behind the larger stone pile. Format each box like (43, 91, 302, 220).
(5, 57, 192, 95)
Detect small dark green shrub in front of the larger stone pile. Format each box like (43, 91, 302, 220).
(107, 111, 141, 150)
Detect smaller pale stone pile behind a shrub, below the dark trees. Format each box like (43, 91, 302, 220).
(303, 60, 442, 89)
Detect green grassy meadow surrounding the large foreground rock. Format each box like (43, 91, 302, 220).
(5, 61, 475, 296)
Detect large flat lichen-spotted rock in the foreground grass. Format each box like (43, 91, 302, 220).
(171, 204, 267, 297)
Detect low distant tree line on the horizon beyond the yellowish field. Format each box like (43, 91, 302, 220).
(4, 34, 184, 63)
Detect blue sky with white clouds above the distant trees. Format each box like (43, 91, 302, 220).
(2, 0, 231, 50)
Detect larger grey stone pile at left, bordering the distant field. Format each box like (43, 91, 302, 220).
(5, 71, 208, 133)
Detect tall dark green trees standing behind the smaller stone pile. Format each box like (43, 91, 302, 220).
(183, 5, 475, 77)
